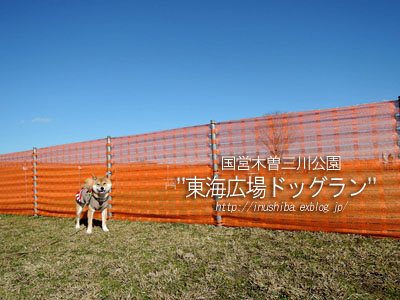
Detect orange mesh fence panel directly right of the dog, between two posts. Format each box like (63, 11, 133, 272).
(111, 125, 215, 224)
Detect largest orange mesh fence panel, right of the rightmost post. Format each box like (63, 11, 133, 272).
(217, 101, 400, 237)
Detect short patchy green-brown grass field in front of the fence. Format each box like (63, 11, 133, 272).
(0, 215, 400, 299)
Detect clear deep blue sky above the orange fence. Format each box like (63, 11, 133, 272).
(0, 0, 400, 153)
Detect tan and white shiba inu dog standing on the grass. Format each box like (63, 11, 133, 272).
(75, 173, 111, 234)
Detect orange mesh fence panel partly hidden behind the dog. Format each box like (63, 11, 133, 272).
(37, 139, 107, 217)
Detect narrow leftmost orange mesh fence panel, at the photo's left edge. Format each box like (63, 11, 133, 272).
(0, 151, 34, 215)
